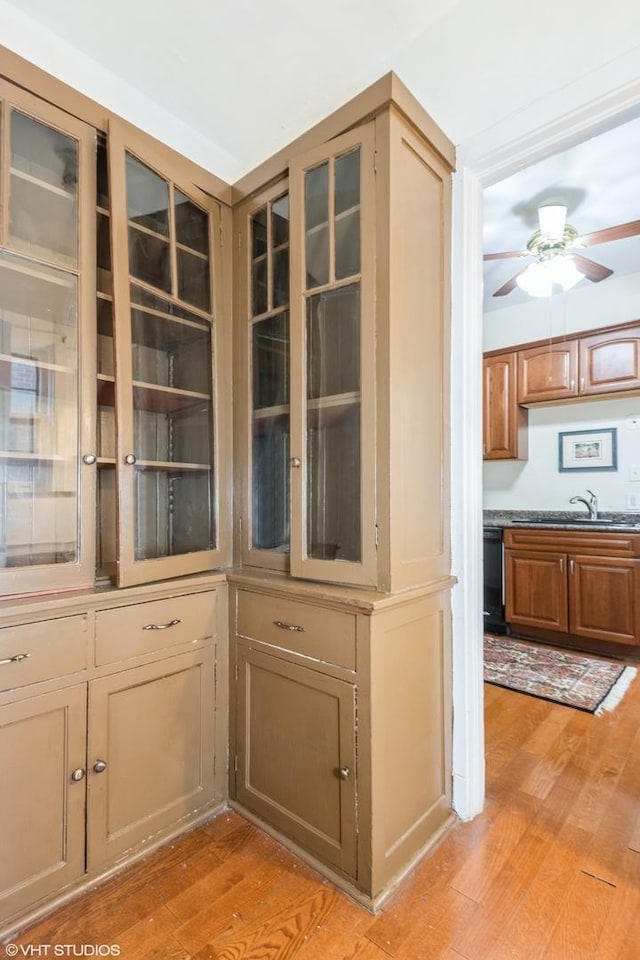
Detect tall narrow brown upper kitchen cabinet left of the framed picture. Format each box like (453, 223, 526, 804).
(482, 352, 528, 460)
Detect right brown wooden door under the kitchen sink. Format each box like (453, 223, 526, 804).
(569, 557, 640, 646)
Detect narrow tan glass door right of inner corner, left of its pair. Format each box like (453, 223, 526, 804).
(240, 184, 290, 570)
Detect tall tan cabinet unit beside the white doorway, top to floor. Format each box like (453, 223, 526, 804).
(230, 76, 453, 904)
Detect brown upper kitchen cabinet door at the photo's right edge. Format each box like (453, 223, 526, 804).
(580, 327, 640, 394)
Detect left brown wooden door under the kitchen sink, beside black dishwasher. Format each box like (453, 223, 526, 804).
(505, 550, 568, 632)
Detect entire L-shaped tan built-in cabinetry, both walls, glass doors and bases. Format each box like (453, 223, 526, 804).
(0, 55, 453, 934)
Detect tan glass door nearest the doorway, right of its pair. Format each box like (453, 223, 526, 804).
(291, 120, 376, 584)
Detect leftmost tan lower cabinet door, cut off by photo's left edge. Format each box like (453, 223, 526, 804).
(0, 684, 87, 927)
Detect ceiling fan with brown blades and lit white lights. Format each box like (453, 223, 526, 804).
(484, 203, 640, 297)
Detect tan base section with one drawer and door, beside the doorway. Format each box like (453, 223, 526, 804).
(230, 573, 453, 907)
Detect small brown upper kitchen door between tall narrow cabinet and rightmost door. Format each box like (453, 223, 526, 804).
(518, 340, 578, 403)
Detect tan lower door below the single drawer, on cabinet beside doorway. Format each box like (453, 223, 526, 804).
(236, 646, 356, 877)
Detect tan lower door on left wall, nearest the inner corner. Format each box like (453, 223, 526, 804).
(87, 647, 215, 870)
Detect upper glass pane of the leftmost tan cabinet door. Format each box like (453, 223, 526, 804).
(9, 110, 78, 266)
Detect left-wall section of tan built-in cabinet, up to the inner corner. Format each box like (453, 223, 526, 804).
(0, 68, 231, 932)
